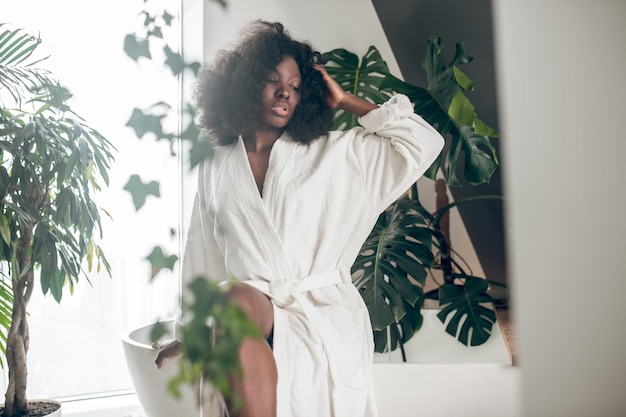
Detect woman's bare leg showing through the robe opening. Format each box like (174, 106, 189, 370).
(224, 284, 278, 417)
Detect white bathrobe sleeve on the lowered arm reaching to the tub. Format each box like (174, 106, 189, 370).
(174, 164, 227, 337)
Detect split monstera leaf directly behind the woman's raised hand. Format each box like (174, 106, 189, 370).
(323, 46, 391, 130)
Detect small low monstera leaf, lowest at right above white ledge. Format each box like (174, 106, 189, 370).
(437, 277, 496, 346)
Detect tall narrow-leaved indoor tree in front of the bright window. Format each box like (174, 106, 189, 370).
(0, 23, 114, 417)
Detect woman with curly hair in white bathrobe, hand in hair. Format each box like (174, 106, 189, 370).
(157, 21, 443, 417)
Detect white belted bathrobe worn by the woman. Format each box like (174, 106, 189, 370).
(183, 95, 444, 417)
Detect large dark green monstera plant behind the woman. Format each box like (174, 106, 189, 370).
(324, 37, 498, 353)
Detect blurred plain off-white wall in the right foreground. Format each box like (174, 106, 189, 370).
(493, 0, 626, 417)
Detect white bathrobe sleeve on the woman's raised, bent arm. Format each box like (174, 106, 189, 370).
(349, 94, 444, 213)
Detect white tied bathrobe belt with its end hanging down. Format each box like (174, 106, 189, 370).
(242, 269, 352, 417)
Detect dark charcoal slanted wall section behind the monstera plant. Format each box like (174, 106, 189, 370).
(372, 0, 506, 290)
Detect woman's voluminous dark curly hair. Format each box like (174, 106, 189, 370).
(193, 20, 334, 145)
